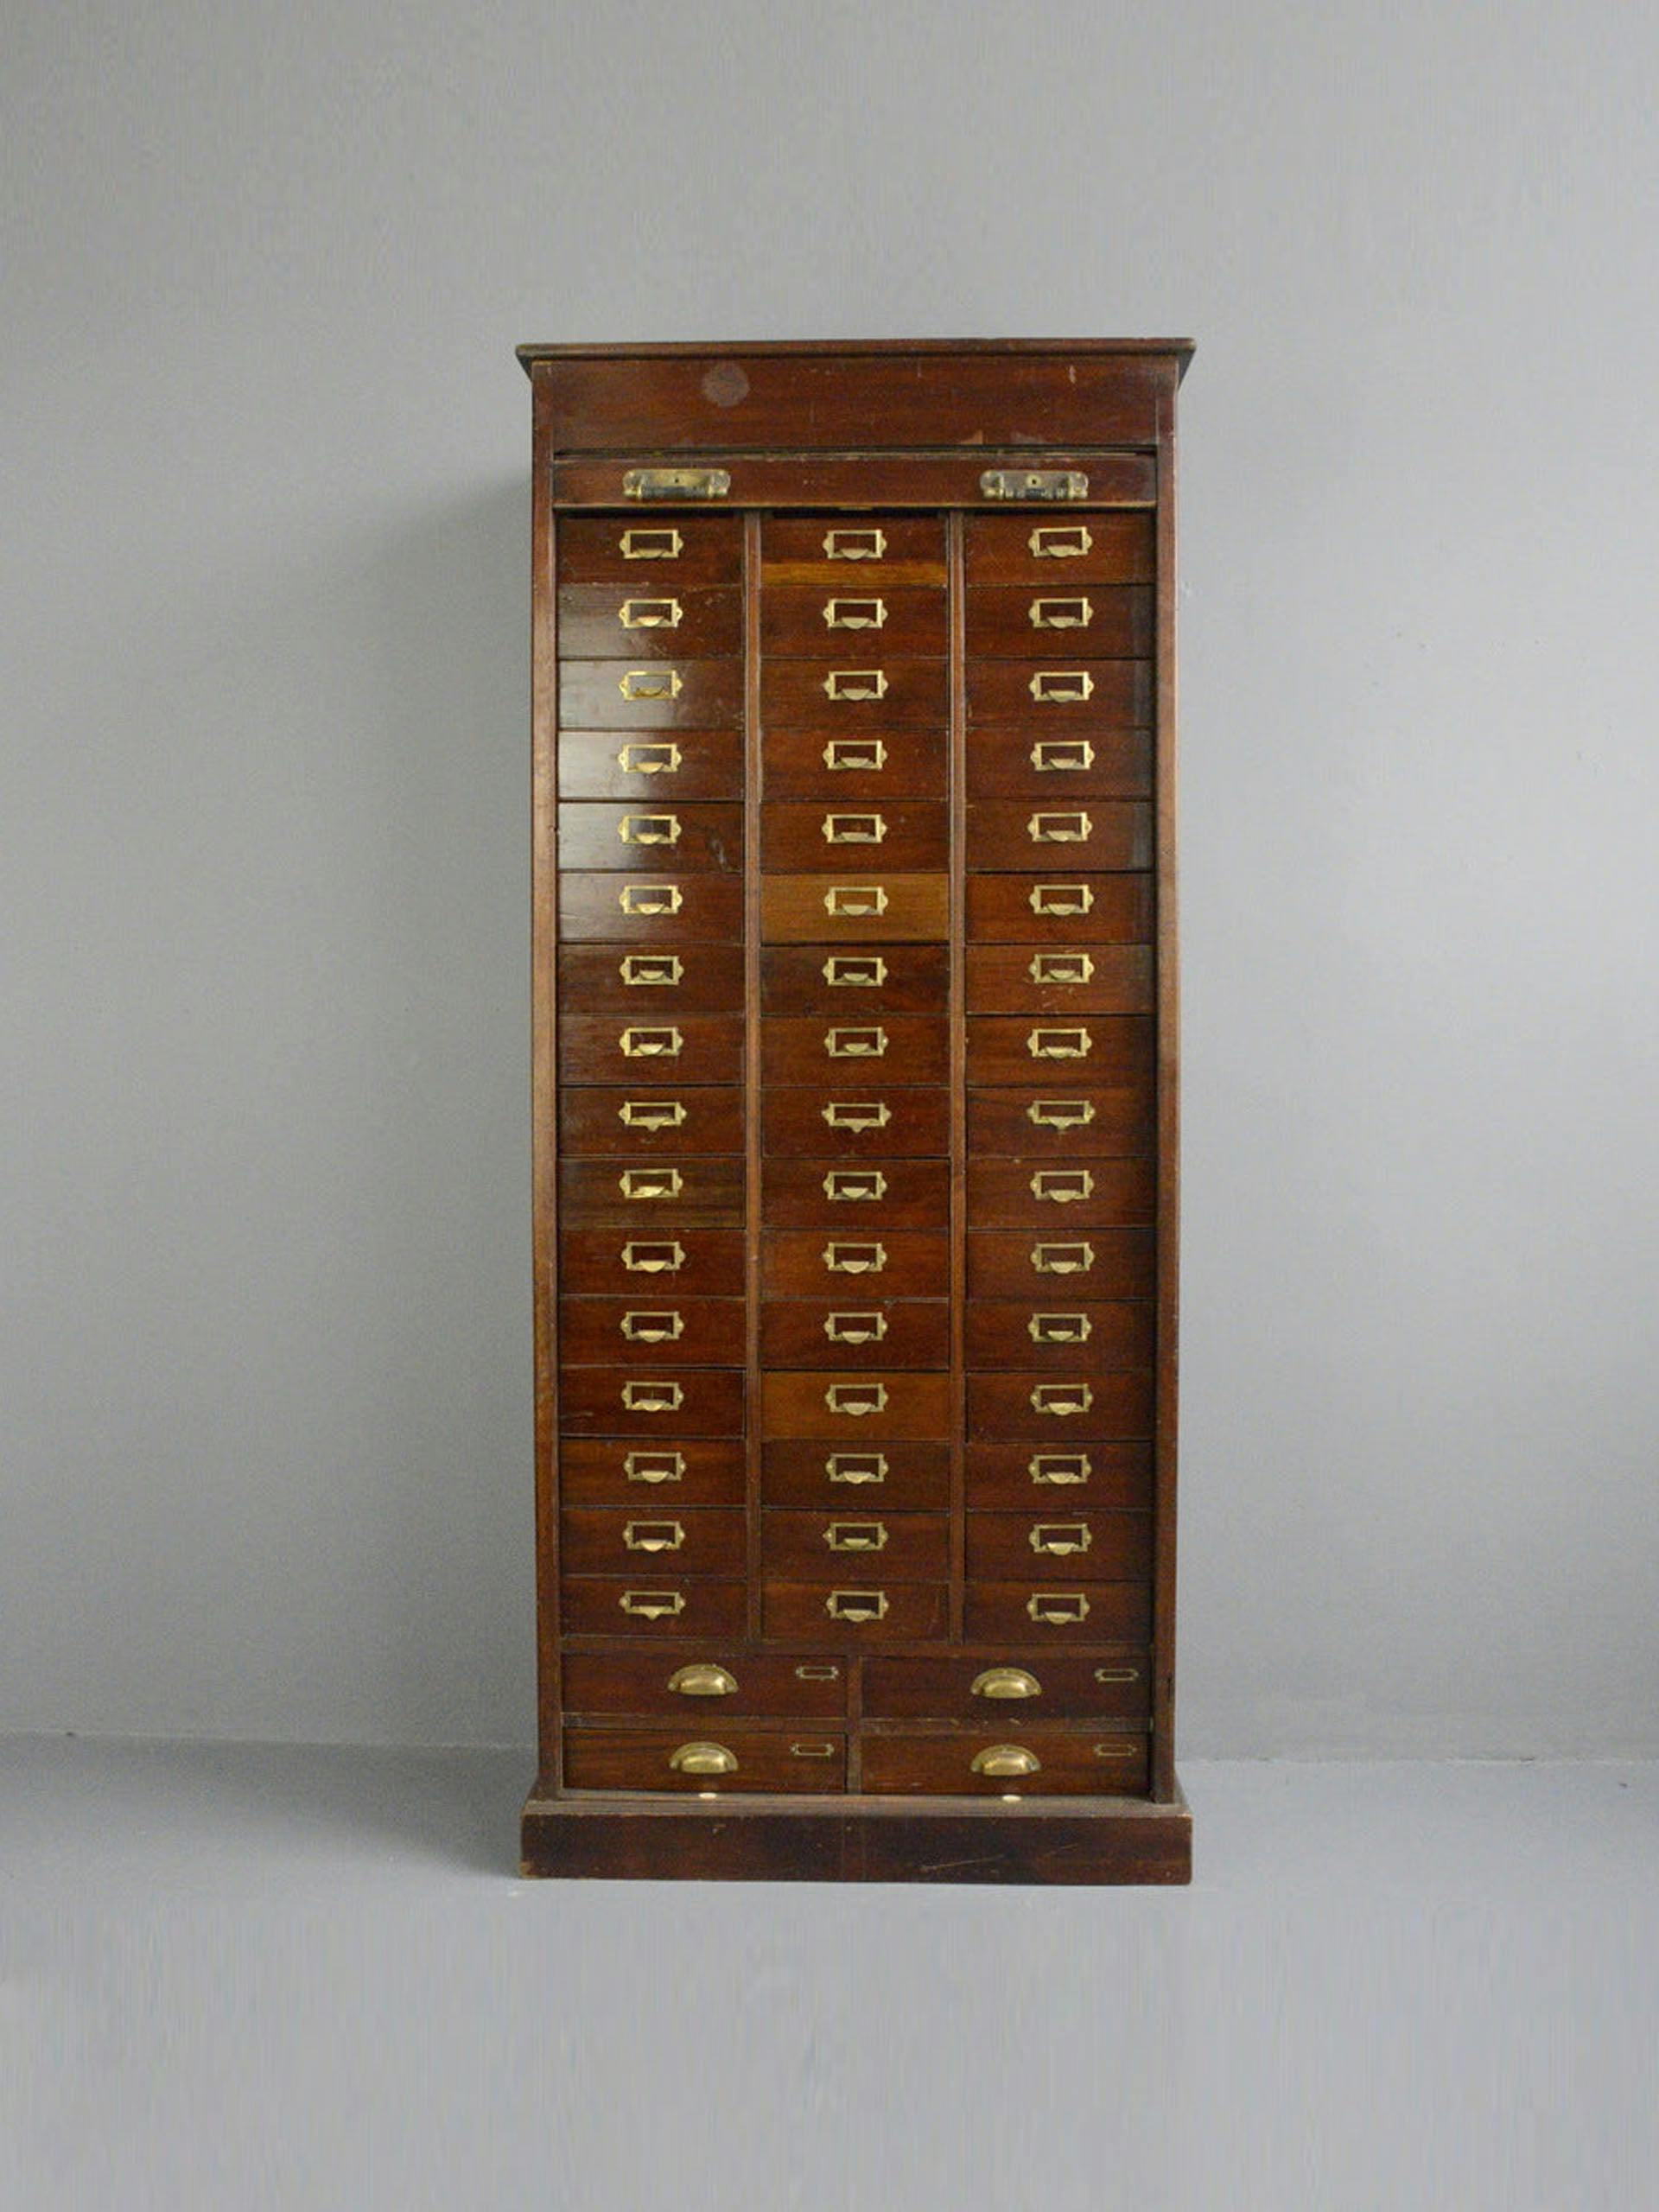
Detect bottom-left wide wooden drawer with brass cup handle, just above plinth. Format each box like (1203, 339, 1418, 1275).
(564, 1712, 847, 1796)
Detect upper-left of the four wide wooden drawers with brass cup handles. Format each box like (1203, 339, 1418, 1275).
(560, 1643, 849, 1734)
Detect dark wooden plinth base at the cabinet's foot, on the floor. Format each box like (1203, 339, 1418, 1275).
(522, 1787, 1192, 1885)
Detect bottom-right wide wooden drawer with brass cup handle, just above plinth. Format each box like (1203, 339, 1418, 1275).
(862, 1714, 1148, 1796)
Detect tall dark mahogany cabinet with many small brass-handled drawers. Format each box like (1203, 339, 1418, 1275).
(520, 340, 1190, 1883)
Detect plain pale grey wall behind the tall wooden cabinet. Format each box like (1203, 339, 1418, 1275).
(0, 0, 1659, 1754)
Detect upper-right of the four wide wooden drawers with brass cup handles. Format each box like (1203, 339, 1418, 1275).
(862, 1643, 1153, 1734)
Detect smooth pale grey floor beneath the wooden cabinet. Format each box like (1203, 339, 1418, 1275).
(0, 1741, 1659, 2212)
